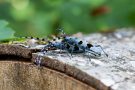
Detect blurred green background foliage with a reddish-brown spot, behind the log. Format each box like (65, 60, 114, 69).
(0, 0, 135, 37)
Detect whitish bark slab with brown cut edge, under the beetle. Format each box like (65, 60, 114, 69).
(33, 29, 135, 90)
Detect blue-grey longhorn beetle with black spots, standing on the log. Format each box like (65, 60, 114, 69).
(36, 29, 108, 64)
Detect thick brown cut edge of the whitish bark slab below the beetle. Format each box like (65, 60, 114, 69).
(32, 54, 109, 90)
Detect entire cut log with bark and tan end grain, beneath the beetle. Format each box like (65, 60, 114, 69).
(0, 28, 135, 90)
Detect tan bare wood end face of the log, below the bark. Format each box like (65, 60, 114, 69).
(0, 60, 95, 90)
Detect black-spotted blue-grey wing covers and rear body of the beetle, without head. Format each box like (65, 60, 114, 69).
(56, 29, 108, 57)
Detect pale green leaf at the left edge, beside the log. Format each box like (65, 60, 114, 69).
(0, 20, 15, 41)
